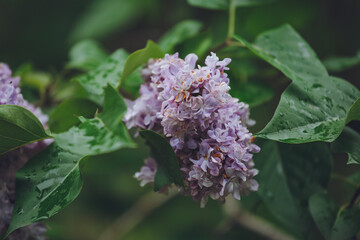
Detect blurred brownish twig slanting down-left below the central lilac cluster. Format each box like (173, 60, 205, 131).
(99, 189, 178, 240)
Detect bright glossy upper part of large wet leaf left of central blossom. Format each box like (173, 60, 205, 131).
(54, 84, 135, 156)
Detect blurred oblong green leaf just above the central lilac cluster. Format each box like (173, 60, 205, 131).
(159, 20, 203, 53)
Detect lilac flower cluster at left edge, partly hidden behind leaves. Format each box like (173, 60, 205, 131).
(0, 63, 50, 240)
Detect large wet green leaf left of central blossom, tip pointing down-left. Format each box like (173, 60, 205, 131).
(4, 85, 135, 236)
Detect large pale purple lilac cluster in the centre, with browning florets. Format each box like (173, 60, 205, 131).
(124, 53, 260, 206)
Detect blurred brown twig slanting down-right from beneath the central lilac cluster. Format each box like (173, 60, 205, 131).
(221, 198, 295, 240)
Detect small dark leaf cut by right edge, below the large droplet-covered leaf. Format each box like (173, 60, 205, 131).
(331, 127, 360, 164)
